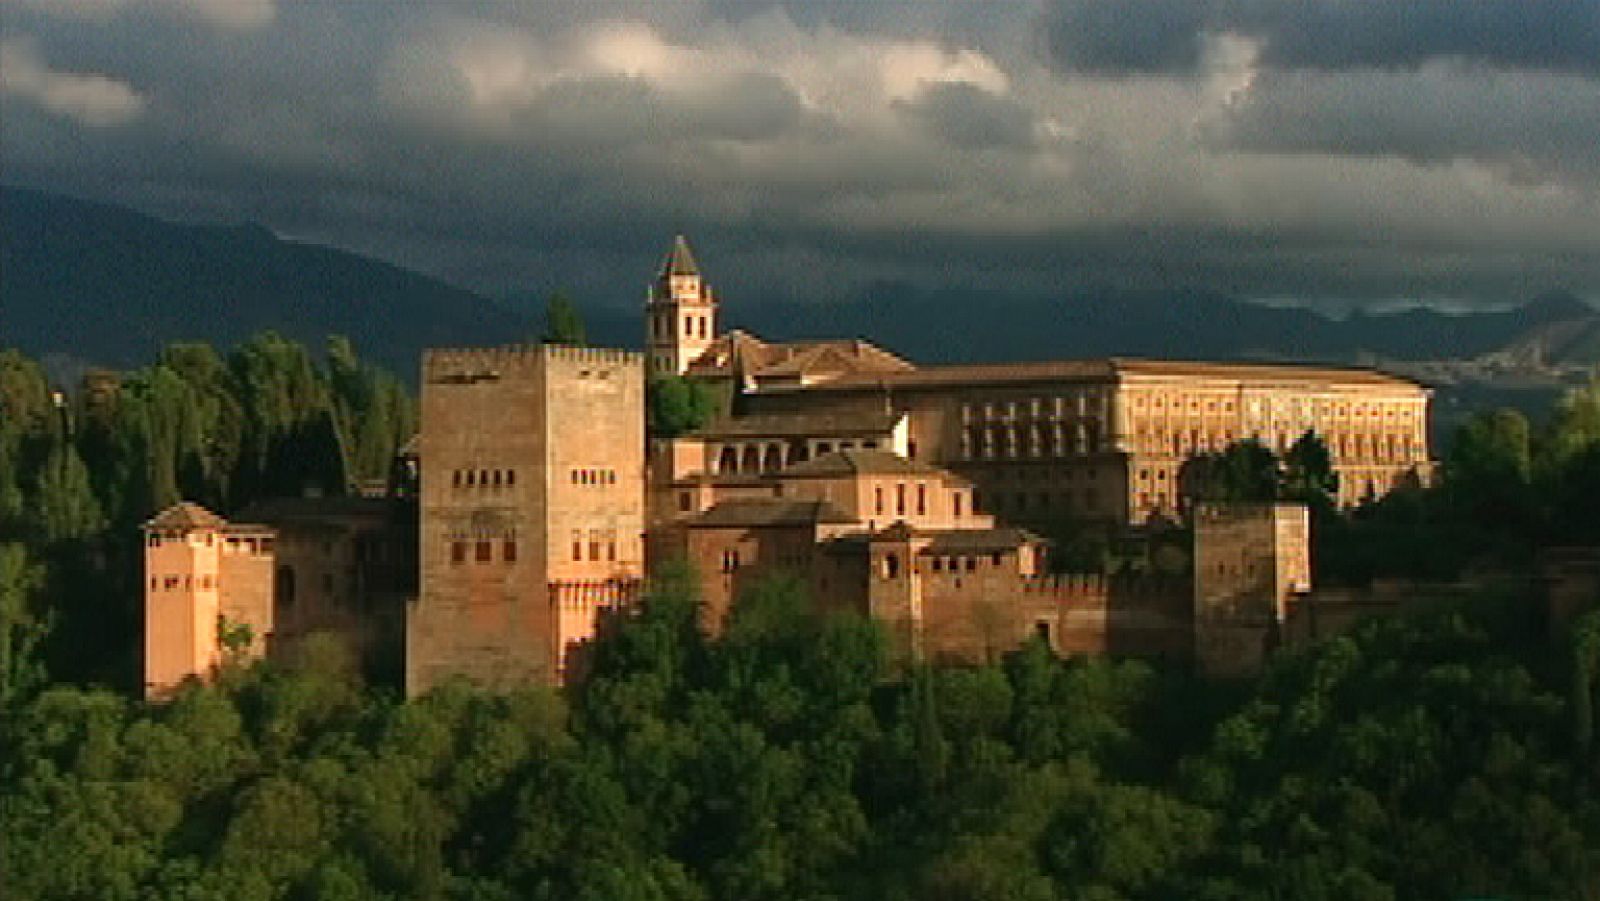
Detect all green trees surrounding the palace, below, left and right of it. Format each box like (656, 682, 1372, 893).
(0, 334, 1600, 901)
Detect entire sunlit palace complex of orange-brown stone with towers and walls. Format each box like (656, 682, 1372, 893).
(146, 237, 1430, 695)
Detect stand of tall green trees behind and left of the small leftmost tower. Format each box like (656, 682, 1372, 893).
(0, 339, 416, 696)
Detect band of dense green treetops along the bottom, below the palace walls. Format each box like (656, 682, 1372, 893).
(0, 581, 1600, 901)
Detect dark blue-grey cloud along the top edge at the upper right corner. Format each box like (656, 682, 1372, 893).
(1043, 0, 1600, 75)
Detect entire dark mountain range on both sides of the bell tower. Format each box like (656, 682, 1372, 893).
(0, 187, 1600, 382)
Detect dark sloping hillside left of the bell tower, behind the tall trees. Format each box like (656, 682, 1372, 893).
(0, 187, 533, 378)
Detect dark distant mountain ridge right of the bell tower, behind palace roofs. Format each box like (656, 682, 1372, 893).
(725, 283, 1600, 363)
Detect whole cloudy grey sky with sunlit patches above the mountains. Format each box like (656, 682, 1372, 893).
(0, 0, 1600, 312)
